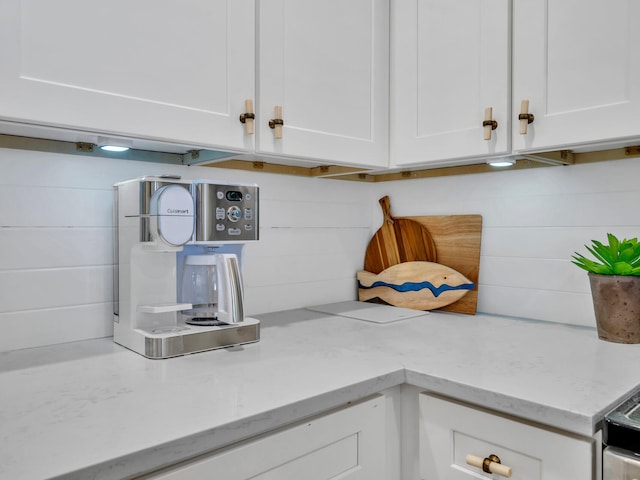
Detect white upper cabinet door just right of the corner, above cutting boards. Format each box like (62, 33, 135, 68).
(391, 0, 510, 166)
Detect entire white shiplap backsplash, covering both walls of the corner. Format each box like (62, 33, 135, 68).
(0, 149, 640, 351)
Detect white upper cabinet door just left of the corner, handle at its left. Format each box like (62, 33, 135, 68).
(256, 0, 389, 167)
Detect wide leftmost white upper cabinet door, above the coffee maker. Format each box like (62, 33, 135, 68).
(0, 0, 255, 150)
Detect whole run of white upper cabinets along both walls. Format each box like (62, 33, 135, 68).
(0, 0, 640, 170)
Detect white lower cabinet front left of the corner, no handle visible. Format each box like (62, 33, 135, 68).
(139, 395, 388, 480)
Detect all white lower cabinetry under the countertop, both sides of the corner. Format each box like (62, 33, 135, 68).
(137, 385, 602, 480)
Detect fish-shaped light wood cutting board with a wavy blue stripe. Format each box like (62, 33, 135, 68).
(356, 261, 476, 310)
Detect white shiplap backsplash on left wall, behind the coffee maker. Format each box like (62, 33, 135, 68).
(0, 149, 371, 352)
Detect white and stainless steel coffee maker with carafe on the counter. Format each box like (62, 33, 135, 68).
(113, 175, 260, 358)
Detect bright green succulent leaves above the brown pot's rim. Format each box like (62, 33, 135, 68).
(571, 233, 640, 276)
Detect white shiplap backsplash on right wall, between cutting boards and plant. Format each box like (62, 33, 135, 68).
(373, 159, 640, 327)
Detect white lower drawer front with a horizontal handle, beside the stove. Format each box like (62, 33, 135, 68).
(420, 394, 594, 480)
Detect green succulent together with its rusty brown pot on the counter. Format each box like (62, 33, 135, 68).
(572, 233, 640, 343)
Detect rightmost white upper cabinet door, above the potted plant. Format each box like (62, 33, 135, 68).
(513, 0, 640, 151)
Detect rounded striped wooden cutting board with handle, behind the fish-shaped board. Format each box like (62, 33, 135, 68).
(364, 196, 438, 273)
